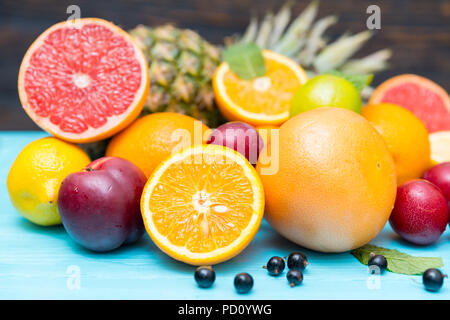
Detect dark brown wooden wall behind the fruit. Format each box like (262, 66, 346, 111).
(0, 0, 450, 130)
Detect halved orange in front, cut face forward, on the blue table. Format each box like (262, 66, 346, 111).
(141, 145, 264, 265)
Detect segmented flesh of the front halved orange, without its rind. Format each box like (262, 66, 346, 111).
(149, 155, 254, 253)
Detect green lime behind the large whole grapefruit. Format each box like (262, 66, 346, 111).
(290, 74, 362, 117)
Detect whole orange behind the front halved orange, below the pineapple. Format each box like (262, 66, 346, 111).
(106, 112, 209, 177)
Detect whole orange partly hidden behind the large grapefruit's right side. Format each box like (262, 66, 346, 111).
(363, 103, 431, 185)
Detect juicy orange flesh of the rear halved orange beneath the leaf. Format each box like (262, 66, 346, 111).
(223, 58, 301, 115)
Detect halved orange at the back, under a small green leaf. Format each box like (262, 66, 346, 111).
(213, 50, 308, 126)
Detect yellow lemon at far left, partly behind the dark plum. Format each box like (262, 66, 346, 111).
(7, 137, 91, 226)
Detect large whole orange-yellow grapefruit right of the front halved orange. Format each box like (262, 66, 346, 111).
(257, 107, 397, 252)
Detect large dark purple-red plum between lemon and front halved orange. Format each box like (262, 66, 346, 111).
(58, 157, 147, 251)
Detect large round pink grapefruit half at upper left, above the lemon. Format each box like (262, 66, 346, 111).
(18, 18, 149, 143)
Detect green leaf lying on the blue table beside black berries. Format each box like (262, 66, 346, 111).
(351, 244, 444, 275)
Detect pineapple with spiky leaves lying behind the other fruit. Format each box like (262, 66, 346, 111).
(83, 0, 391, 158)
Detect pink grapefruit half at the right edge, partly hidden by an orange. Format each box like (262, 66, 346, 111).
(369, 74, 450, 133)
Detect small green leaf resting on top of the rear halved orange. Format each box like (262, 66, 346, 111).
(223, 43, 267, 80)
